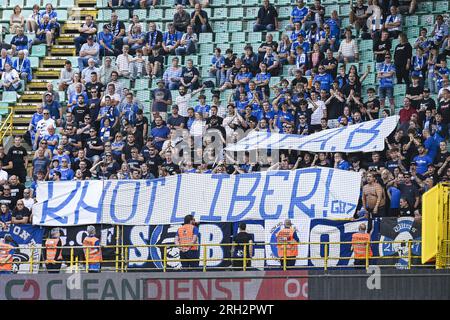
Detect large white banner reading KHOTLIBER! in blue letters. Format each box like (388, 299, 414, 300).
(33, 167, 361, 226)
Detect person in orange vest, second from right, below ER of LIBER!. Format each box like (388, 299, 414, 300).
(276, 219, 300, 269)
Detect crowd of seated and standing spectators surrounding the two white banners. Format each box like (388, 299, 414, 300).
(0, 0, 450, 226)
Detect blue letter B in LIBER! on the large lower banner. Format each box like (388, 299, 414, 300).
(227, 173, 261, 222)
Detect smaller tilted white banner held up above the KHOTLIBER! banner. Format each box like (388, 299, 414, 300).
(226, 116, 399, 153)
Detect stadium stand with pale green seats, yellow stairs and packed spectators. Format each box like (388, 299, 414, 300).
(0, 0, 450, 272)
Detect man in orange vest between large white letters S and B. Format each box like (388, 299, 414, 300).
(175, 214, 200, 270)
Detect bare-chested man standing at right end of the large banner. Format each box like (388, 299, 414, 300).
(362, 172, 386, 217)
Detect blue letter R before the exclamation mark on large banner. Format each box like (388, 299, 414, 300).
(288, 168, 322, 219)
